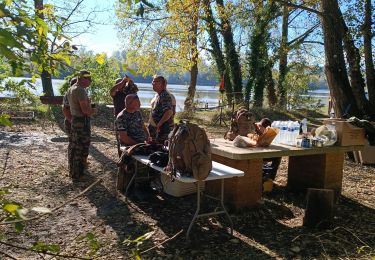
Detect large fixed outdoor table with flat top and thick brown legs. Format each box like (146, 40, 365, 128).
(206, 138, 363, 209)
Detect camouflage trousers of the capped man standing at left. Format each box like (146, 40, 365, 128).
(68, 116, 91, 179)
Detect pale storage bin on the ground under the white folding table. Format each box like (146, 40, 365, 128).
(161, 174, 205, 197)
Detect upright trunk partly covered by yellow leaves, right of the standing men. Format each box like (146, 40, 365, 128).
(184, 0, 199, 111)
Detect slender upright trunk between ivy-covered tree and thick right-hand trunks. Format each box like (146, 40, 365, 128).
(277, 5, 289, 108)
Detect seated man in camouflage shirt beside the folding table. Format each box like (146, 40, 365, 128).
(115, 94, 150, 146)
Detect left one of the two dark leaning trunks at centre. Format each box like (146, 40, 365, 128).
(203, 0, 233, 104)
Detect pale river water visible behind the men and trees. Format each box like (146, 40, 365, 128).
(0, 78, 329, 111)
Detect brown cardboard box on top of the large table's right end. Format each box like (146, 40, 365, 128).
(323, 118, 365, 146)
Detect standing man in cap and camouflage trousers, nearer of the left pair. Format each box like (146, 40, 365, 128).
(65, 70, 96, 180)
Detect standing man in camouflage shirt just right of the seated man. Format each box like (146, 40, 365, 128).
(148, 76, 173, 144)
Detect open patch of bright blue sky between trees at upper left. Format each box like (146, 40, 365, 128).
(73, 0, 121, 56)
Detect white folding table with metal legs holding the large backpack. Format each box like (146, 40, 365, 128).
(118, 148, 244, 240)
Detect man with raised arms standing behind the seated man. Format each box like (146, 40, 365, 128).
(110, 75, 138, 116)
